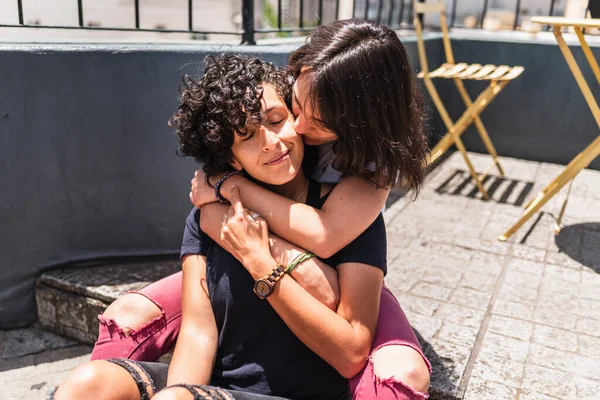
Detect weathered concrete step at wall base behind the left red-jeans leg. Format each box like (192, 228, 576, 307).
(35, 259, 181, 343)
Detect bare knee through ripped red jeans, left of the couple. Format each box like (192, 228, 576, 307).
(102, 293, 162, 335)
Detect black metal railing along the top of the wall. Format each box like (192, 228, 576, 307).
(0, 0, 572, 44)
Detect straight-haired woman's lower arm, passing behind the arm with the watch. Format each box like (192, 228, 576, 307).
(200, 203, 340, 311)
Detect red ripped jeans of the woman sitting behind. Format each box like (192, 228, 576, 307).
(91, 272, 431, 400)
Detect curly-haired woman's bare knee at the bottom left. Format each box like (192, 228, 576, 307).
(54, 362, 107, 400)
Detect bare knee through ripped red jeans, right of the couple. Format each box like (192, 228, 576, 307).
(372, 345, 430, 393)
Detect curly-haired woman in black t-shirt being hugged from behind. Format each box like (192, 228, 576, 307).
(53, 55, 416, 400)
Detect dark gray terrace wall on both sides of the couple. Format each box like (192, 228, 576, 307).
(0, 35, 600, 328)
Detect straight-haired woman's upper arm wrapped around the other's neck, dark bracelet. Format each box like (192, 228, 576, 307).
(190, 170, 389, 258)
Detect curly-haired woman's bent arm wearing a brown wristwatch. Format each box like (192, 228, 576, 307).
(221, 190, 383, 378)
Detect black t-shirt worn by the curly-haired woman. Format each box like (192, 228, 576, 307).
(181, 181, 387, 400)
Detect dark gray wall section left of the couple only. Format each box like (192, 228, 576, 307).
(0, 45, 291, 328)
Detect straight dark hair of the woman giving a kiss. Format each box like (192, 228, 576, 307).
(288, 20, 428, 195)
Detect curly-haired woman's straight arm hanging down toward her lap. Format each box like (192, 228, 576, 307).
(167, 255, 218, 385)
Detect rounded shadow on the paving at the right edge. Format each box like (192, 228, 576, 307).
(555, 222, 600, 273)
